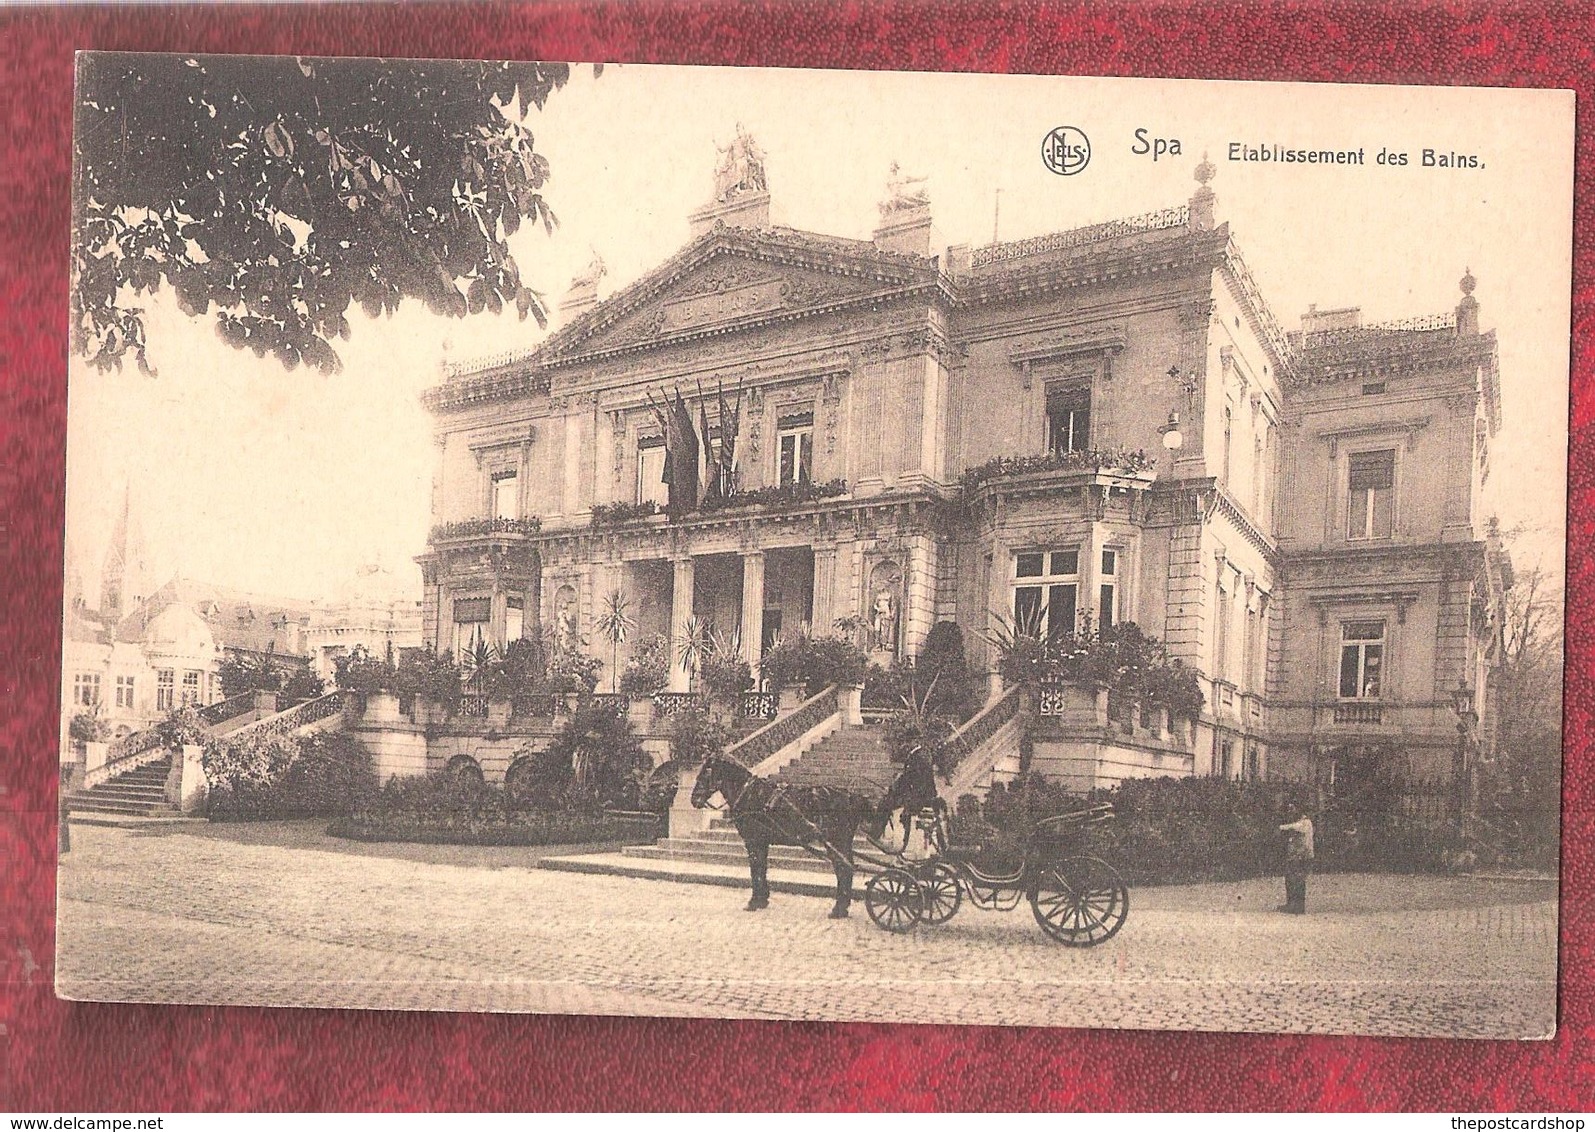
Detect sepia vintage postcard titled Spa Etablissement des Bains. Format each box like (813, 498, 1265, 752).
(57, 53, 1573, 1038)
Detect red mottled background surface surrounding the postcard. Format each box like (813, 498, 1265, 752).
(0, 2, 1595, 1113)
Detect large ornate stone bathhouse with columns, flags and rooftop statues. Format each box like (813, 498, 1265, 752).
(419, 137, 1506, 786)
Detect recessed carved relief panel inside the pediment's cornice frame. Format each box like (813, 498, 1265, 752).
(557, 252, 887, 357)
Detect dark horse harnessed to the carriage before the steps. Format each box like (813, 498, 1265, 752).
(692, 754, 876, 920)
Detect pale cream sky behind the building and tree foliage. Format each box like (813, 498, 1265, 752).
(67, 65, 1573, 609)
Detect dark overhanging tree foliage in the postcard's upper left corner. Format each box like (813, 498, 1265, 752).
(72, 54, 583, 371)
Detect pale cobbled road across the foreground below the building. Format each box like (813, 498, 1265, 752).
(57, 823, 1557, 1038)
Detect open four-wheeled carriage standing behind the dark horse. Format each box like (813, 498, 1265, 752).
(864, 804, 1129, 947)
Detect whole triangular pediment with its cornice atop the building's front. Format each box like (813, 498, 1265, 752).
(539, 230, 936, 364)
